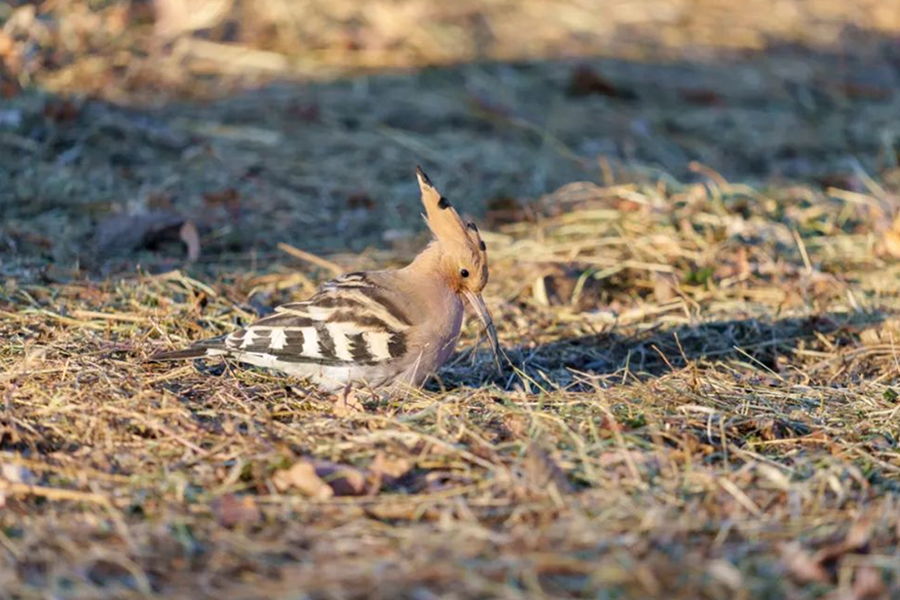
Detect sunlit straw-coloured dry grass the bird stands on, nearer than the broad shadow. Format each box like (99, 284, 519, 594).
(0, 176, 900, 597)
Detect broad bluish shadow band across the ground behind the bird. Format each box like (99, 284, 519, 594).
(0, 27, 900, 282)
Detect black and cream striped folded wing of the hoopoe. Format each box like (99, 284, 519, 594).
(223, 273, 411, 368)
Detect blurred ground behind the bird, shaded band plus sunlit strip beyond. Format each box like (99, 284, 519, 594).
(0, 0, 900, 280)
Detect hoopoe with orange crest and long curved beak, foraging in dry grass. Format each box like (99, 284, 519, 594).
(151, 167, 500, 392)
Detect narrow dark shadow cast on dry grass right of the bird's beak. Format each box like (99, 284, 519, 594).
(430, 313, 885, 391)
